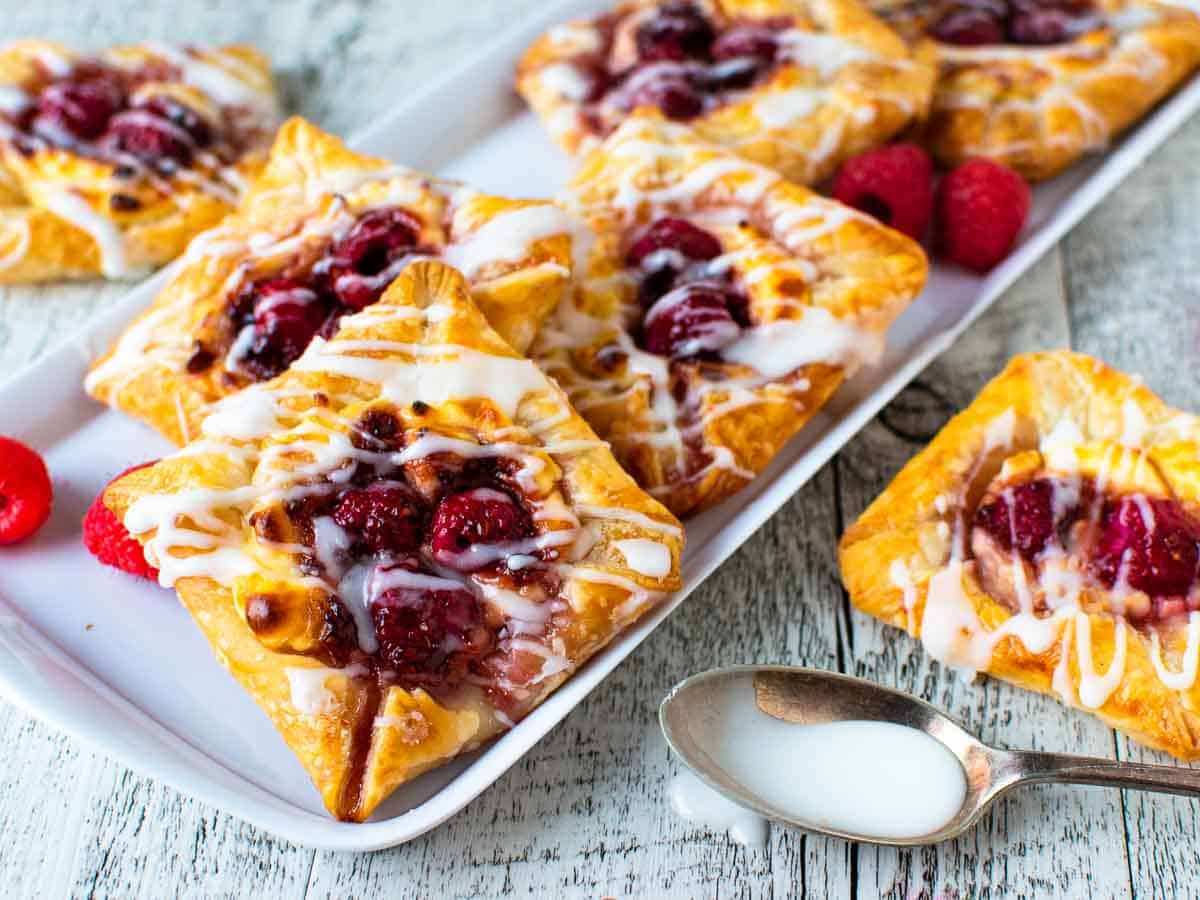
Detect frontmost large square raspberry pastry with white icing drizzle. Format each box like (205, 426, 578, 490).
(106, 262, 683, 821)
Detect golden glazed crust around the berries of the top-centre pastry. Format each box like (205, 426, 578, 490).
(517, 0, 934, 184)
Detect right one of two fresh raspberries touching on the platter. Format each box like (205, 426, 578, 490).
(937, 160, 1030, 272)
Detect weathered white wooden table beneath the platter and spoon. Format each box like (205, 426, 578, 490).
(0, 0, 1200, 898)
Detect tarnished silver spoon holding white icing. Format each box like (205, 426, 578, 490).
(659, 666, 1200, 846)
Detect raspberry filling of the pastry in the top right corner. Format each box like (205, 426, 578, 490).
(930, 0, 1102, 47)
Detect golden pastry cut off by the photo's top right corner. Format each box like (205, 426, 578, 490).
(870, 0, 1200, 181)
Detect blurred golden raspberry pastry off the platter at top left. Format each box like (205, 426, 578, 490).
(0, 41, 280, 283)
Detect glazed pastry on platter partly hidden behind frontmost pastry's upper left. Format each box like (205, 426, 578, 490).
(86, 119, 576, 444)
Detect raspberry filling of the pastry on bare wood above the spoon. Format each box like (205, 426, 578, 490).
(972, 478, 1200, 622)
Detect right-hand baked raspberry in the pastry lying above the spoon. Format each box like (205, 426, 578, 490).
(1091, 494, 1200, 596)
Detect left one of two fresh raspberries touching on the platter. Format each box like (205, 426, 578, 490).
(833, 144, 934, 240)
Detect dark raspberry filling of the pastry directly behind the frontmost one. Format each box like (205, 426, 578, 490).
(187, 206, 436, 382)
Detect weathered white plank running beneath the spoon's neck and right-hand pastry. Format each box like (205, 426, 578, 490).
(838, 252, 1129, 898)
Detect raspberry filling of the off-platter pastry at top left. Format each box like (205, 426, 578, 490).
(4, 60, 239, 174)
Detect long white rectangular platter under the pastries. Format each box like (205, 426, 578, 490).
(0, 0, 1200, 850)
